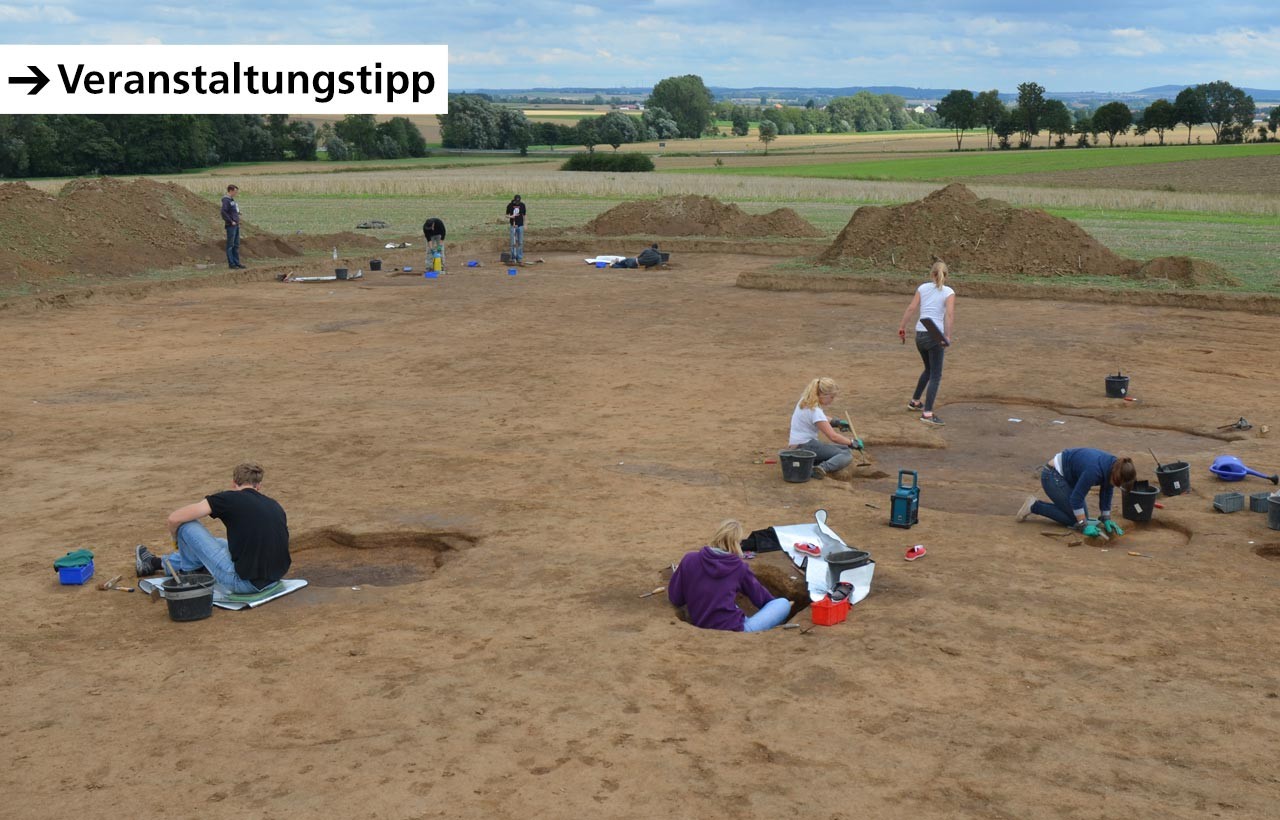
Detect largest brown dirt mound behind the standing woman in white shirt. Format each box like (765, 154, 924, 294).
(819, 183, 1139, 276)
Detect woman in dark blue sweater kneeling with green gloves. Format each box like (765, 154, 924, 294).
(1018, 446, 1138, 539)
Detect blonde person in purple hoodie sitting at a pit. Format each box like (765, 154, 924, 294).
(667, 519, 791, 632)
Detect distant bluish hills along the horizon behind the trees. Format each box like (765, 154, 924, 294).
(458, 83, 1280, 105)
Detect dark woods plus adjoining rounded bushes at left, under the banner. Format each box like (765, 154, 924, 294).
(0, 114, 428, 179)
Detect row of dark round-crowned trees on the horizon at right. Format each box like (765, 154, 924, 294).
(938, 81, 1259, 150)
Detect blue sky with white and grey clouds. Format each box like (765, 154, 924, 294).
(0, 0, 1280, 91)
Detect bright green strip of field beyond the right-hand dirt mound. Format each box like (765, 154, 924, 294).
(664, 143, 1280, 180)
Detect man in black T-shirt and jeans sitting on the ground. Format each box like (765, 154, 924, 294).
(134, 463, 291, 594)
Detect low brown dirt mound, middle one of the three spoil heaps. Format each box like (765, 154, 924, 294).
(585, 194, 822, 238)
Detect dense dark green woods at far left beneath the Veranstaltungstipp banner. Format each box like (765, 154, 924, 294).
(0, 114, 316, 178)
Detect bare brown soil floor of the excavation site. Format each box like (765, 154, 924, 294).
(0, 185, 1280, 819)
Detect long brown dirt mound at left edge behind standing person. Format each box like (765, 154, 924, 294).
(0, 177, 379, 287)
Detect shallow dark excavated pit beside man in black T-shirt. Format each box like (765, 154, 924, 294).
(289, 527, 477, 587)
